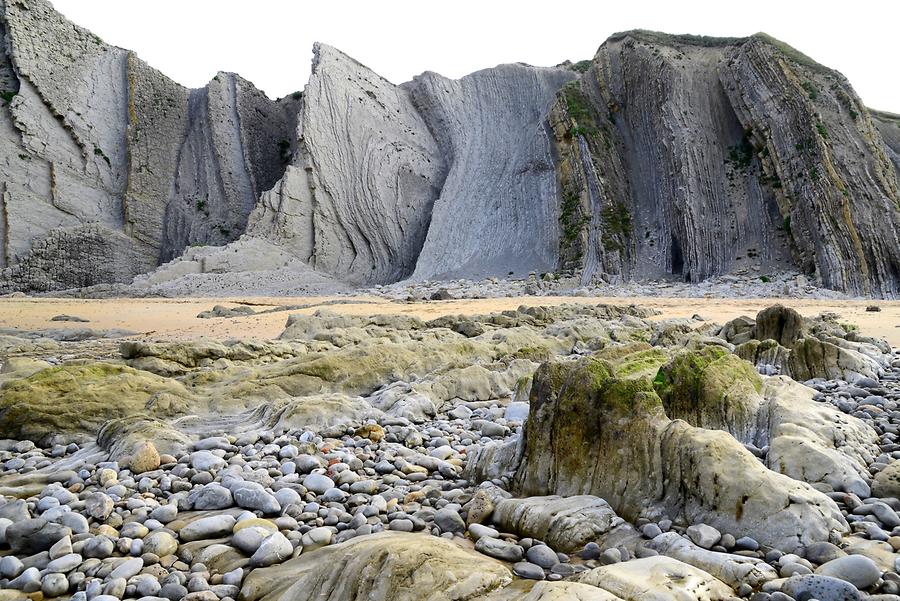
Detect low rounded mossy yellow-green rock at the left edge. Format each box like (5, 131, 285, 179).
(0, 362, 191, 440)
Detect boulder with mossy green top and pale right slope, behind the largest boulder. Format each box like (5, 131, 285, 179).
(654, 346, 879, 498)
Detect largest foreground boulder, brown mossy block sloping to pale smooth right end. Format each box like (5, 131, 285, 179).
(515, 358, 847, 551)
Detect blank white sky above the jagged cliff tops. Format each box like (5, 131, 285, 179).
(54, 0, 900, 112)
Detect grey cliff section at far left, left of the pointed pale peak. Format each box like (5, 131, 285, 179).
(0, 0, 297, 290)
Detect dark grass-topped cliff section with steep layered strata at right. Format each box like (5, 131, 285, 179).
(553, 32, 900, 294)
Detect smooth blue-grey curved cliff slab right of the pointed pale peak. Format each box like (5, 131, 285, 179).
(408, 64, 576, 279)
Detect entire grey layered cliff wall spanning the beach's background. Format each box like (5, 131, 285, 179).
(0, 0, 900, 295)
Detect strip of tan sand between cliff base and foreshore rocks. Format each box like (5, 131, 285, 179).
(0, 296, 900, 347)
